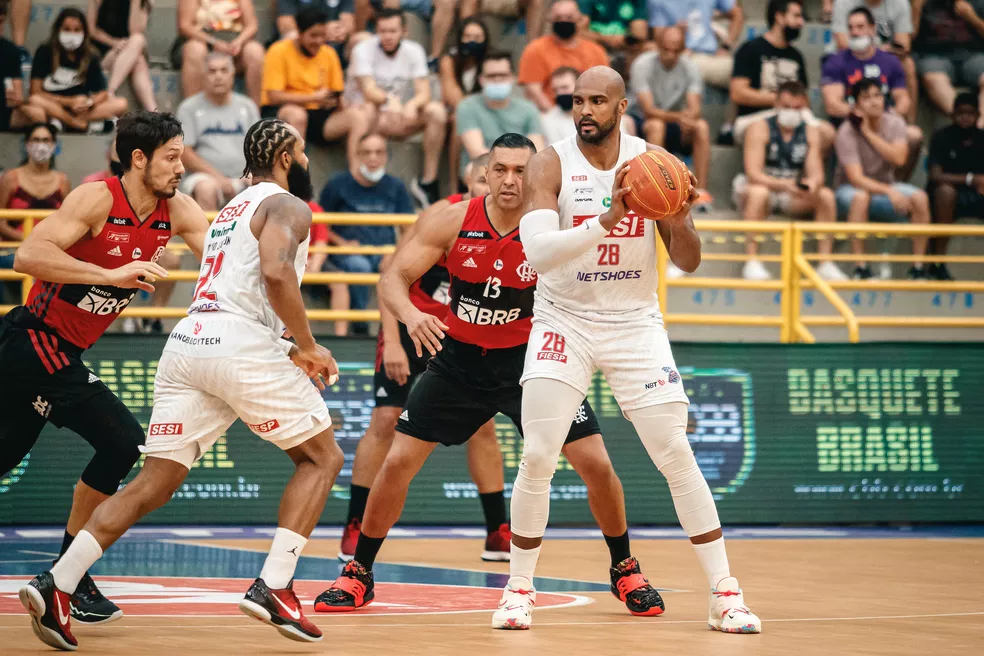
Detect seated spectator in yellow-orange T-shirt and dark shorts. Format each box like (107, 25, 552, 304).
(263, 8, 355, 157)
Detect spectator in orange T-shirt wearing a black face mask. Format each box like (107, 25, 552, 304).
(519, 0, 609, 112)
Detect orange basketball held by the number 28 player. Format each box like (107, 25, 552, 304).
(624, 150, 690, 221)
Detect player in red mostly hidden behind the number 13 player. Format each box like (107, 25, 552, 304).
(338, 153, 511, 562)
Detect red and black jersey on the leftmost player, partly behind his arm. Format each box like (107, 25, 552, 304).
(27, 178, 171, 349)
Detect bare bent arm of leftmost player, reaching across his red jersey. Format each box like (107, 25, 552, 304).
(14, 182, 167, 292)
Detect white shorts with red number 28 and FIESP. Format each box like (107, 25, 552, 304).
(520, 301, 690, 413)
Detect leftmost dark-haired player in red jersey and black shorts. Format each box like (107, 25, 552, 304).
(0, 112, 208, 624)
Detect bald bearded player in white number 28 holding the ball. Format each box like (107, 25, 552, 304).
(492, 66, 761, 633)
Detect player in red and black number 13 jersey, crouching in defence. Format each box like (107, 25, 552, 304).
(314, 134, 663, 614)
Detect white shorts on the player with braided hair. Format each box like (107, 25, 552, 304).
(140, 320, 331, 469)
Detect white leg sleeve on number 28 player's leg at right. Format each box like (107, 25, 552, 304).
(626, 402, 721, 537)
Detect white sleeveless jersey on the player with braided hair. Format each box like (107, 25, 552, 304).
(188, 182, 311, 337)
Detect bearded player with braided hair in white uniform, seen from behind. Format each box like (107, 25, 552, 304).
(20, 119, 344, 650)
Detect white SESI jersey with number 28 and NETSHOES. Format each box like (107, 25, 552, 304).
(537, 134, 659, 318)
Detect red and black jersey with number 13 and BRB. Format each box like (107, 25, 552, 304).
(444, 196, 536, 349)
